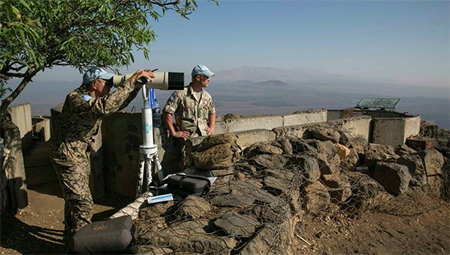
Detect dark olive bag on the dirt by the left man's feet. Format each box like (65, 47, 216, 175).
(69, 215, 138, 254)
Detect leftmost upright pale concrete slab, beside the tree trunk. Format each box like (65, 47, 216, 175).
(8, 104, 33, 150)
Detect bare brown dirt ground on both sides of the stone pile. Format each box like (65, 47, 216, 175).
(0, 175, 450, 254)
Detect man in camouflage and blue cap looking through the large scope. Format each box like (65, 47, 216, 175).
(51, 67, 154, 242)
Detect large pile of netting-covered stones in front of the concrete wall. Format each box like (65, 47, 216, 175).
(133, 125, 444, 254)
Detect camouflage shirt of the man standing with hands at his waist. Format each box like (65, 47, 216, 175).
(163, 85, 216, 136)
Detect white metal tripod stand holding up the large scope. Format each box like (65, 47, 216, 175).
(136, 85, 164, 197)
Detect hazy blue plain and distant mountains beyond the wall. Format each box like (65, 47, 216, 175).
(13, 66, 450, 129)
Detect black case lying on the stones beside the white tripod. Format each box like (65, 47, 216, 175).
(167, 174, 211, 197)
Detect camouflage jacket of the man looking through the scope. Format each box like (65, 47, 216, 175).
(53, 77, 139, 146)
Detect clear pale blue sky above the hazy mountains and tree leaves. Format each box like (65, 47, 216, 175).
(34, 0, 450, 87)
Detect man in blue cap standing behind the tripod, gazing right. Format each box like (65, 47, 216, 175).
(162, 65, 216, 170)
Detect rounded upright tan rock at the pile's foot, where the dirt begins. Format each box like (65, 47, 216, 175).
(304, 182, 330, 214)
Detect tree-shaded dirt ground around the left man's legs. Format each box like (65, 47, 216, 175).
(0, 183, 131, 254)
